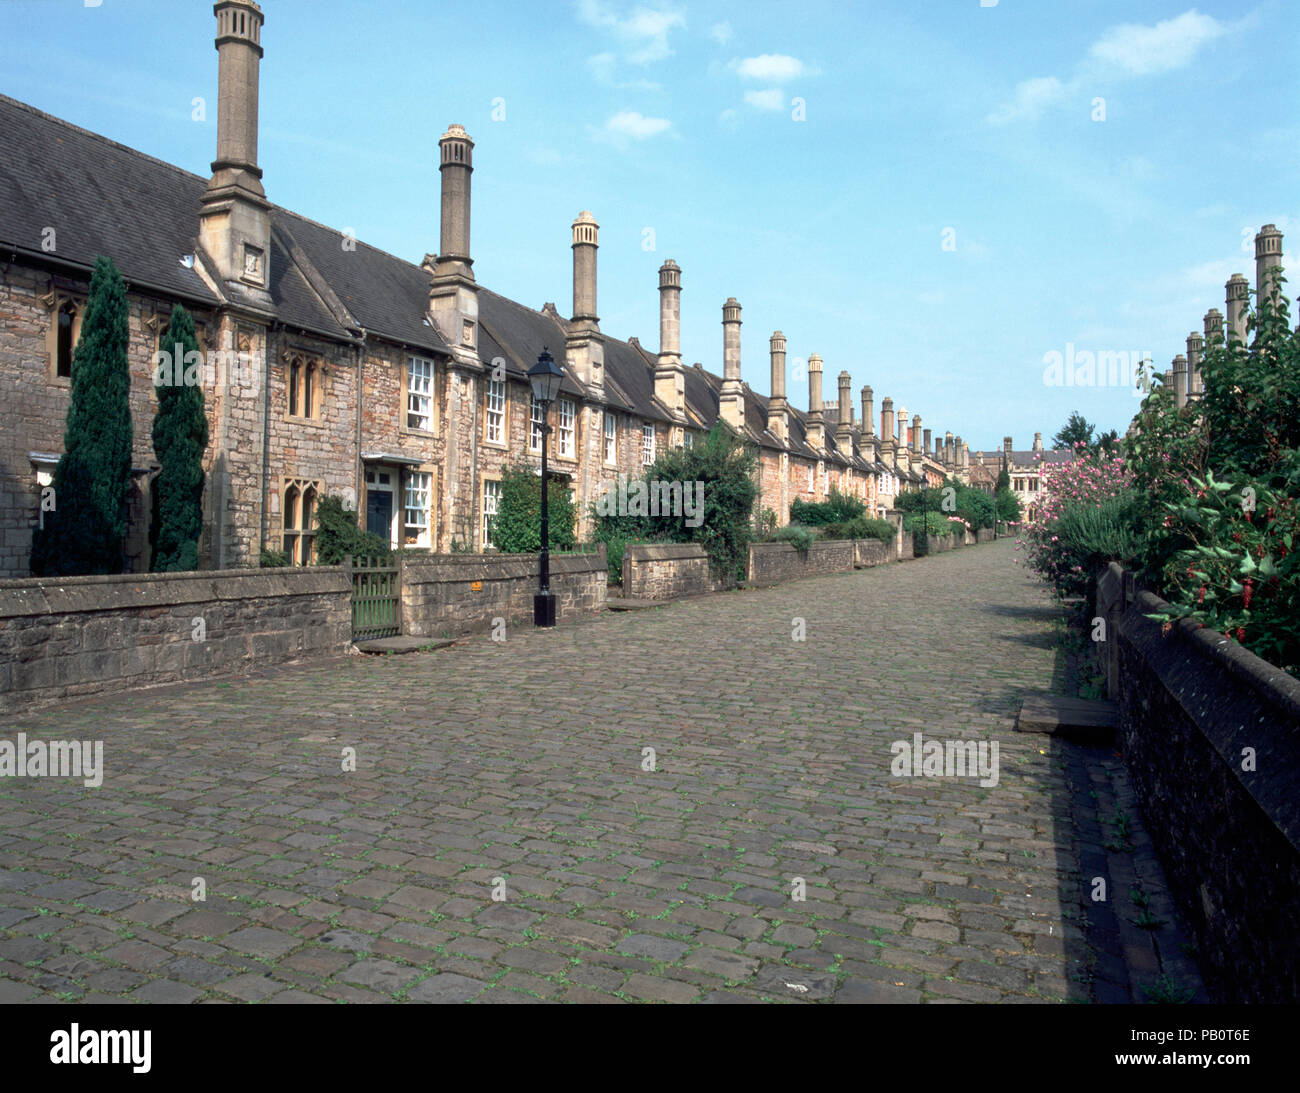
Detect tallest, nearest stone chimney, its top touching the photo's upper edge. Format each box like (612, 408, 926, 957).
(199, 0, 273, 311)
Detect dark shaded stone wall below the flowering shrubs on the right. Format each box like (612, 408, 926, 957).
(1097, 565, 1300, 1003)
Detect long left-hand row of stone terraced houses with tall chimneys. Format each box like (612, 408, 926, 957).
(0, 0, 969, 577)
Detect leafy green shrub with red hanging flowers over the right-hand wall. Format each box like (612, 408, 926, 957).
(1126, 273, 1300, 675)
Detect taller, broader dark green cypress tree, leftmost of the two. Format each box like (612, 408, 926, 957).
(31, 256, 133, 577)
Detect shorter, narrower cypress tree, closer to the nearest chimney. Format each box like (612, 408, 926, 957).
(150, 304, 208, 573)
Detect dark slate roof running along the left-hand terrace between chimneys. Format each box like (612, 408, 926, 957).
(0, 95, 935, 481)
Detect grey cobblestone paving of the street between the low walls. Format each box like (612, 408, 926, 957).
(0, 541, 1195, 1002)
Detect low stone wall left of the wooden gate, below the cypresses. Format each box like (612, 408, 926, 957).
(0, 567, 352, 712)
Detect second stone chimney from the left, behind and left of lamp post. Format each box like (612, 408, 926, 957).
(429, 125, 478, 365)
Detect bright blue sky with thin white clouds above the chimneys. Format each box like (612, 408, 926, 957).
(0, 0, 1300, 452)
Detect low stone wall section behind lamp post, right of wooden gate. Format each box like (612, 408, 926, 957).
(402, 543, 608, 638)
